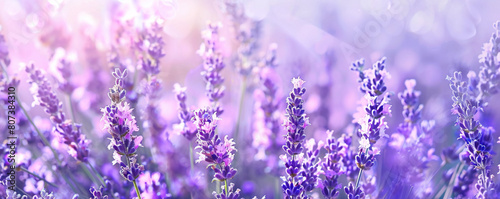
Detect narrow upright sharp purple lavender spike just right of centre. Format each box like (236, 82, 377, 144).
(280, 78, 310, 199)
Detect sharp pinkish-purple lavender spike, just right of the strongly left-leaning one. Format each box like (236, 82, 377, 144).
(101, 69, 144, 199)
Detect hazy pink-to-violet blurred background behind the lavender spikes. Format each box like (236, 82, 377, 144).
(0, 0, 500, 198)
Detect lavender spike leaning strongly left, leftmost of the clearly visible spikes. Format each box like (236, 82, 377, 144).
(25, 64, 89, 162)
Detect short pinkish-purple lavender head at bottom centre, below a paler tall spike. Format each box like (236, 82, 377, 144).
(193, 108, 239, 197)
